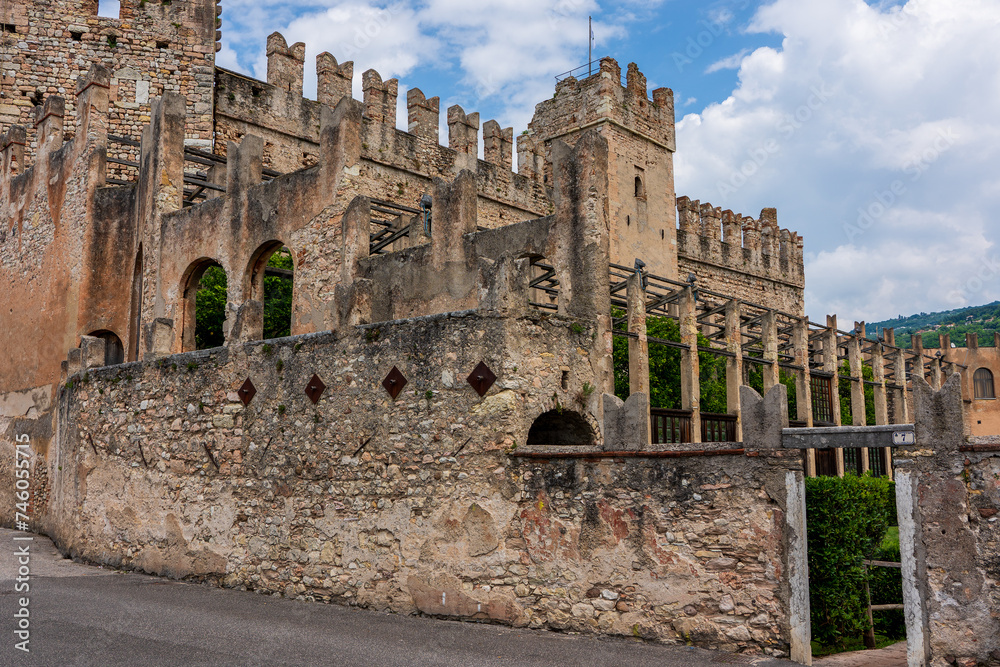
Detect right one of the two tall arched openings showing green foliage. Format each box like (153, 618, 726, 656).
(244, 241, 295, 339)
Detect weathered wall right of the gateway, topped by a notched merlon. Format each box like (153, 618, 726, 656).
(895, 375, 1000, 667)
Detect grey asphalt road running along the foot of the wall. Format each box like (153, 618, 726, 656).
(0, 529, 794, 667)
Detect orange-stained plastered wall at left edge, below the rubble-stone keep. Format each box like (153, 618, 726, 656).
(0, 68, 136, 394)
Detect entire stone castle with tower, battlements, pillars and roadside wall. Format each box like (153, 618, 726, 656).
(0, 0, 988, 661)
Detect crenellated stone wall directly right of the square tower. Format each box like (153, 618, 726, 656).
(677, 197, 805, 315)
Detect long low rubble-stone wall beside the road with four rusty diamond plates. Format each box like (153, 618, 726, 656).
(42, 313, 788, 655)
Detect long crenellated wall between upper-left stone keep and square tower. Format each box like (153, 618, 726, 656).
(215, 33, 552, 235)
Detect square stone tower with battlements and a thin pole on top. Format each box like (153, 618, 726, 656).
(518, 58, 677, 278)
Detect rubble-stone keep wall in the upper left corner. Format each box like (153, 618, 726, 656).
(0, 0, 216, 160)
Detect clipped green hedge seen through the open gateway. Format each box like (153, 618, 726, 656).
(806, 475, 893, 646)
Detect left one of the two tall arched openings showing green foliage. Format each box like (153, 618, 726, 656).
(181, 257, 229, 352)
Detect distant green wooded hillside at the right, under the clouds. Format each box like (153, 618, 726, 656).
(865, 301, 1000, 348)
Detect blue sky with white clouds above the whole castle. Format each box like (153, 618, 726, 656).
(199, 0, 1000, 323)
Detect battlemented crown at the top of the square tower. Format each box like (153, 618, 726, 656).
(528, 58, 677, 152)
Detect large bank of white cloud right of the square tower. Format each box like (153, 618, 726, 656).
(676, 0, 1000, 320)
